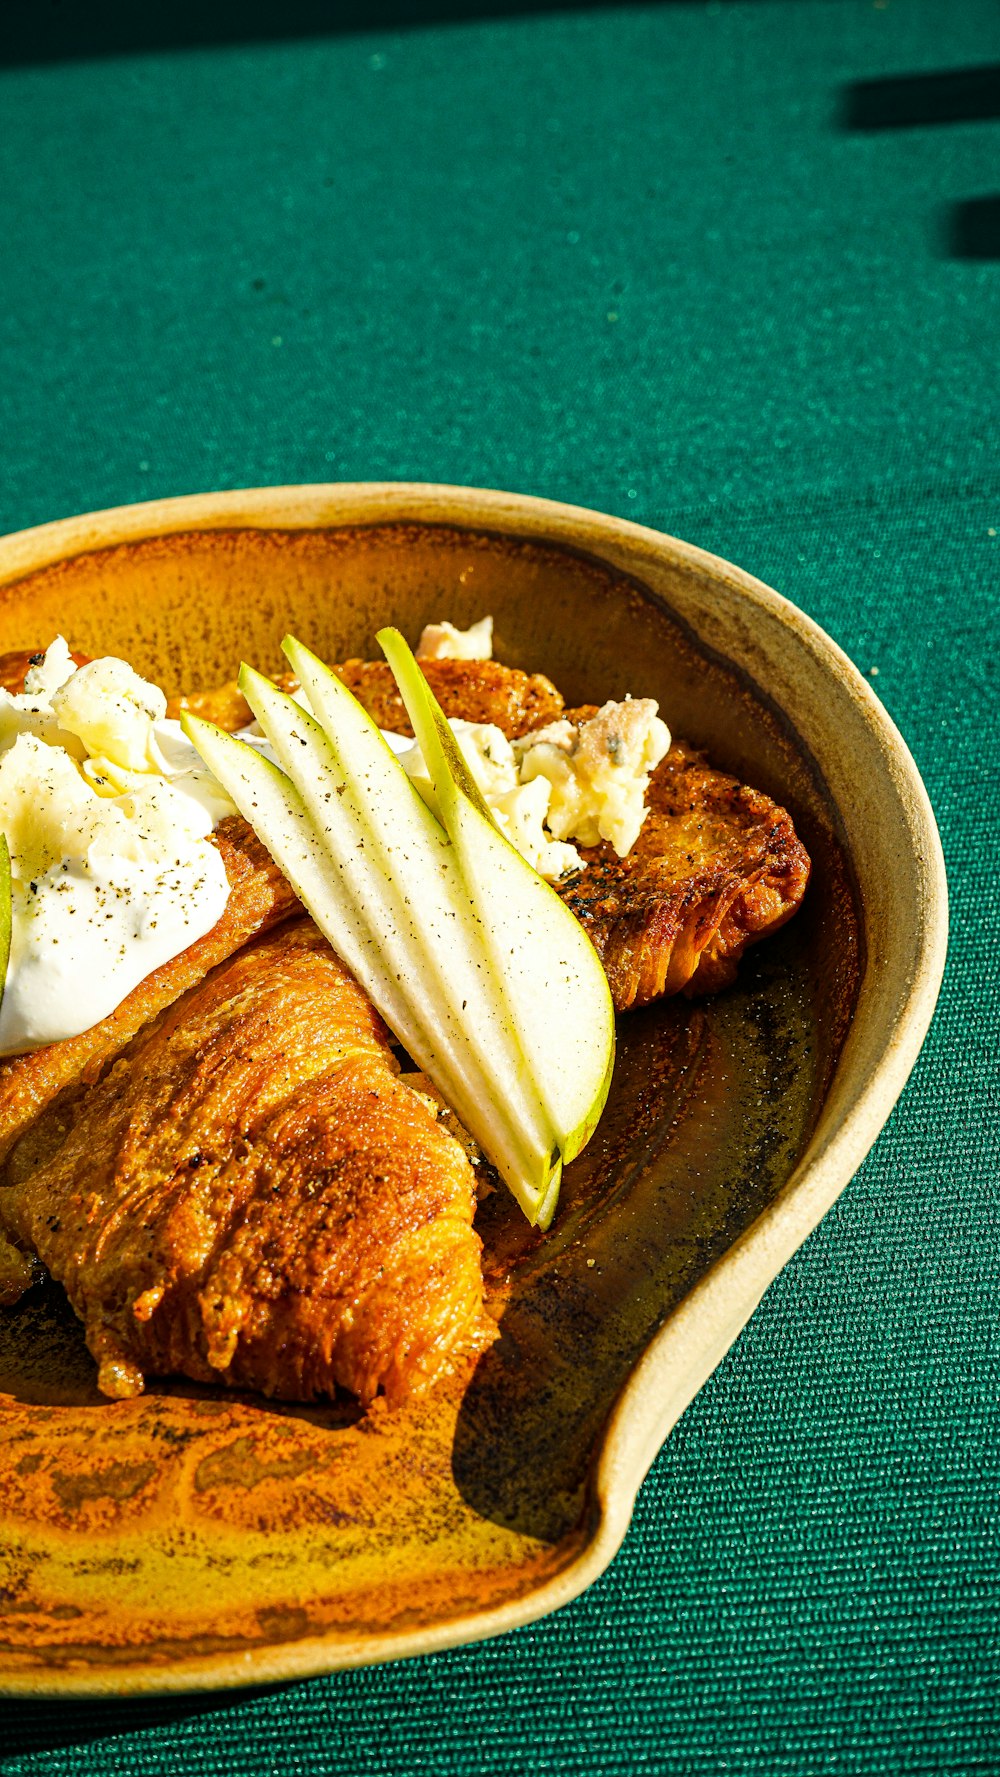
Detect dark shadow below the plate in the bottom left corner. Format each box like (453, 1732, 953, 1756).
(0, 1685, 288, 1770)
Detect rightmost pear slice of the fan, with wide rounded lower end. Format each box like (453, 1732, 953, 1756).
(378, 629, 615, 1162)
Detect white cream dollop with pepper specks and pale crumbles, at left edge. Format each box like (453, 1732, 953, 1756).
(0, 638, 234, 1056)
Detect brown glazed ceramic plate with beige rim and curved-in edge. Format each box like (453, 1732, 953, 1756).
(0, 483, 947, 1697)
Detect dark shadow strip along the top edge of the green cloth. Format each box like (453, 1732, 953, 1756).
(0, 0, 852, 68)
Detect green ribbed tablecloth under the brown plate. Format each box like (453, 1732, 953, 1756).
(0, 0, 1000, 1777)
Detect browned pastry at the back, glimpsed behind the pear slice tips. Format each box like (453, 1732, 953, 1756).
(167, 659, 563, 739)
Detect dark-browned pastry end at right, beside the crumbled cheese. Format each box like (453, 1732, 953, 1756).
(560, 741, 810, 1011)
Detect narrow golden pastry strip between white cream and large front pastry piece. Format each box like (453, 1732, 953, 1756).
(0, 816, 300, 1162)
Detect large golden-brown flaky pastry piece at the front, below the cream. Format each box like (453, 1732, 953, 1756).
(0, 919, 483, 1402)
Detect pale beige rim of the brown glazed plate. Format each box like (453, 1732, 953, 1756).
(0, 482, 948, 1701)
